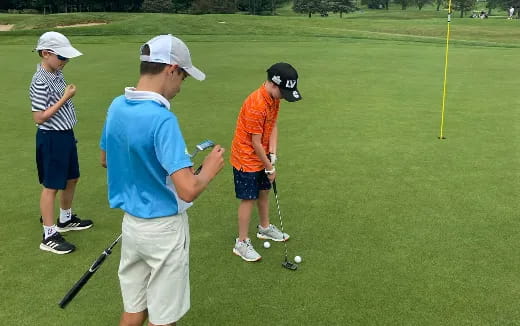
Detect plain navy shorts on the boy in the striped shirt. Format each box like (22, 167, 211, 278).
(36, 129, 79, 189)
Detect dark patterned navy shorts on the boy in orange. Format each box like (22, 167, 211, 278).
(233, 168, 271, 199)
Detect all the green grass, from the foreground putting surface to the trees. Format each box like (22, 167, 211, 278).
(0, 10, 520, 326)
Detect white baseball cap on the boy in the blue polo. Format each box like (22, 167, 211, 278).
(140, 34, 206, 80)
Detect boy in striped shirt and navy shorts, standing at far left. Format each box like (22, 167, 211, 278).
(29, 32, 93, 254)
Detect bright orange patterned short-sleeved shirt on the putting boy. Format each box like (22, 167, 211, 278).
(230, 85, 280, 172)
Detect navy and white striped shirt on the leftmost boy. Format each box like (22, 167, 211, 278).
(29, 64, 78, 130)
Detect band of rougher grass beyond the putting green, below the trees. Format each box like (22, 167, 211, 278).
(0, 10, 520, 47)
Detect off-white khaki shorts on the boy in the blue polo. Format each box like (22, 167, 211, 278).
(119, 213, 190, 325)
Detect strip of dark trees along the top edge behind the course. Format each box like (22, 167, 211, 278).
(0, 0, 520, 18)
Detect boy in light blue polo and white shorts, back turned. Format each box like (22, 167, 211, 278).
(100, 35, 224, 326)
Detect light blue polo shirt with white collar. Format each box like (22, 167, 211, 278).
(100, 87, 193, 218)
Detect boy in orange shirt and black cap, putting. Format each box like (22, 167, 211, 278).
(231, 62, 301, 261)
